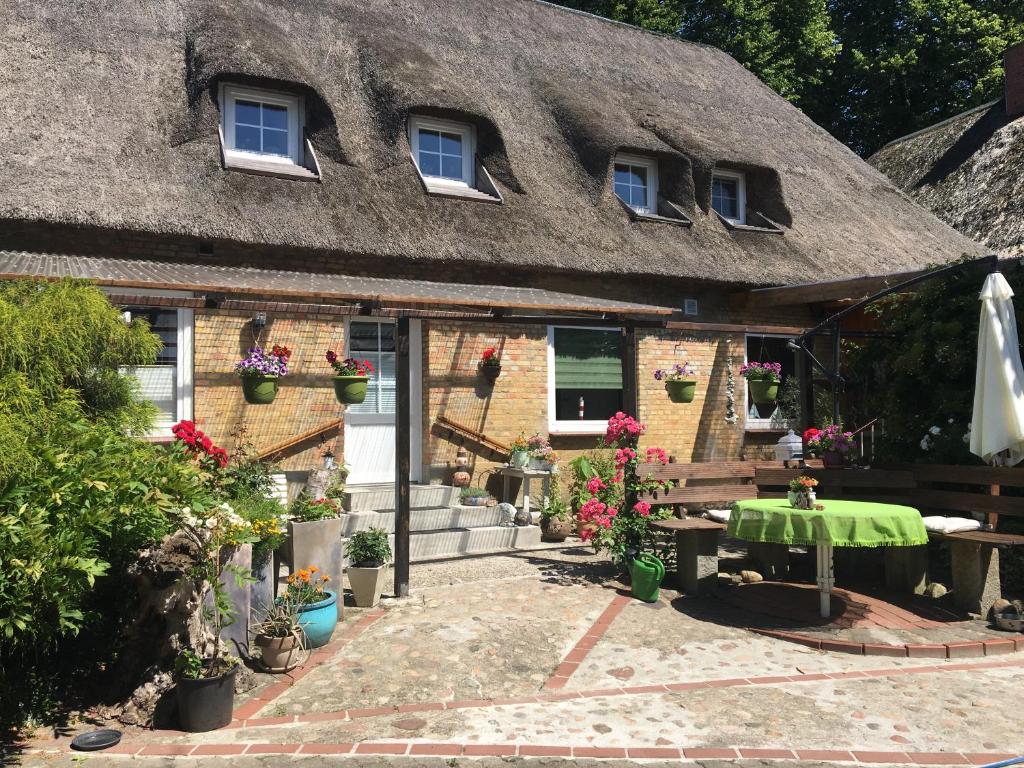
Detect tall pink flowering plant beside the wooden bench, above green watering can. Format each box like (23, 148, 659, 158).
(572, 413, 672, 564)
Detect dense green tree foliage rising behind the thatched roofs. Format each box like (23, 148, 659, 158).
(560, 0, 1024, 155)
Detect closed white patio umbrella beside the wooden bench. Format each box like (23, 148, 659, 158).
(971, 272, 1024, 465)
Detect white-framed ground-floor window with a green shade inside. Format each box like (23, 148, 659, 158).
(548, 326, 623, 434)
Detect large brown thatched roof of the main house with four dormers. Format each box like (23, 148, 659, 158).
(0, 0, 977, 285)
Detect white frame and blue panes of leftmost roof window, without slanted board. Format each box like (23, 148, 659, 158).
(220, 85, 303, 166)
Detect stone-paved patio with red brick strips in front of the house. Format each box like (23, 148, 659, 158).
(24, 549, 1024, 766)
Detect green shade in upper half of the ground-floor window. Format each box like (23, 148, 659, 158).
(555, 328, 623, 389)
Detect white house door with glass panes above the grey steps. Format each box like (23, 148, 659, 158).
(345, 319, 422, 485)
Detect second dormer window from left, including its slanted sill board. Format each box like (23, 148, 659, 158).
(409, 115, 502, 203)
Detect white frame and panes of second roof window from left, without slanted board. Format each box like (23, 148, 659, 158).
(409, 115, 476, 189)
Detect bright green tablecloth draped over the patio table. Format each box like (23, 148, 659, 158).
(728, 499, 928, 547)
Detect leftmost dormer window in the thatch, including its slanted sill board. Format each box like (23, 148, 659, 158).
(220, 85, 319, 179)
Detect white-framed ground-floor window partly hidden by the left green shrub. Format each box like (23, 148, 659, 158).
(103, 288, 196, 437)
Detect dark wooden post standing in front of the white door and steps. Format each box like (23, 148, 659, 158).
(394, 314, 412, 597)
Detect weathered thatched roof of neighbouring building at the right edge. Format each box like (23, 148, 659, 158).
(869, 99, 1024, 256)
